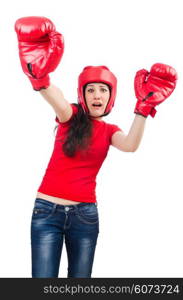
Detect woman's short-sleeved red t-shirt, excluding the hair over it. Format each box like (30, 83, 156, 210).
(38, 104, 121, 202)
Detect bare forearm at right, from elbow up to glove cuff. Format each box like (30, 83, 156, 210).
(125, 115, 146, 152)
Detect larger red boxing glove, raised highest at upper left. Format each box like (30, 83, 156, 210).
(15, 17, 64, 91)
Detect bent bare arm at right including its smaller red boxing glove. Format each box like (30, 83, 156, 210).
(112, 63, 177, 152)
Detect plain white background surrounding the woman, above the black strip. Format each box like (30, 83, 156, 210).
(0, 0, 183, 277)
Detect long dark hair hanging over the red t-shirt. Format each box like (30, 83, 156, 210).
(54, 103, 93, 157)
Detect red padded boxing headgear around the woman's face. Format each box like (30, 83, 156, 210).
(78, 66, 117, 116)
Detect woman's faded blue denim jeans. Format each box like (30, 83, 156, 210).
(31, 198, 99, 278)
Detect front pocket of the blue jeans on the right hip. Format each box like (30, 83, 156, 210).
(77, 204, 99, 224)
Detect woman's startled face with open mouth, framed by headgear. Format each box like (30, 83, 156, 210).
(85, 82, 110, 120)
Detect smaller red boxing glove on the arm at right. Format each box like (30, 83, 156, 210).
(134, 63, 177, 117)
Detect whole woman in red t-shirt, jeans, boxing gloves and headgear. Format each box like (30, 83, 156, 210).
(15, 17, 177, 277)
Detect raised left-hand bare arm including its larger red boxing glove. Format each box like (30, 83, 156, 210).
(15, 17, 72, 122)
